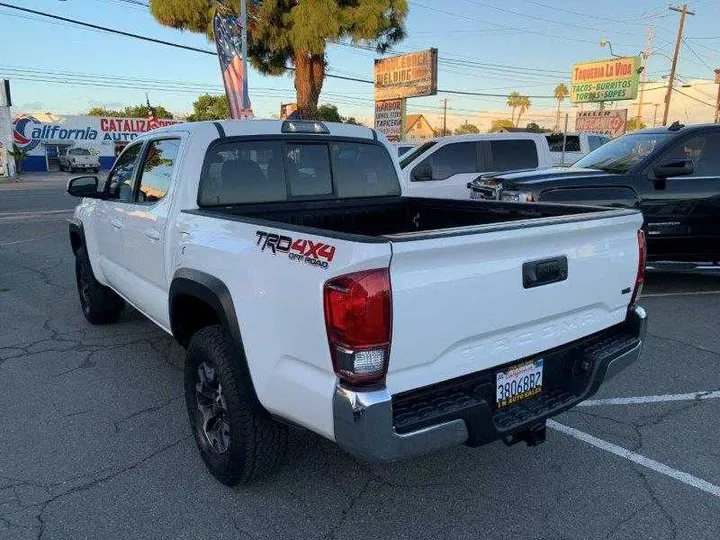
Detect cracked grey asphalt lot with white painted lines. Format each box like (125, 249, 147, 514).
(0, 175, 720, 540)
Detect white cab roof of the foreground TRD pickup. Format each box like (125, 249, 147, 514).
(149, 120, 381, 140)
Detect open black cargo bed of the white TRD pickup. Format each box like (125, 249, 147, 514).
(193, 197, 606, 237)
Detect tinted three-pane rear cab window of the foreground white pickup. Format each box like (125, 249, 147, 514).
(198, 137, 400, 207)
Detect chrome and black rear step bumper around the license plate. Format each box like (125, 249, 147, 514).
(333, 307, 647, 461)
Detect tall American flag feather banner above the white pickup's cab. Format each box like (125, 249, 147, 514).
(213, 13, 253, 119)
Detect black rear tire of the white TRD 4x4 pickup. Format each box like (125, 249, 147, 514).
(185, 326, 288, 486)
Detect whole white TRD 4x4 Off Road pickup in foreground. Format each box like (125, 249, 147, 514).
(68, 120, 646, 485)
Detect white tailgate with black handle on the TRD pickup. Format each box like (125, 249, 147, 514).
(387, 211, 642, 394)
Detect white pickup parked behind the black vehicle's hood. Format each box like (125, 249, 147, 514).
(400, 133, 552, 199)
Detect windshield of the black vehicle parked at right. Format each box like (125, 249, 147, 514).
(572, 133, 672, 173)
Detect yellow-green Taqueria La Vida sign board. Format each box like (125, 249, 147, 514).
(570, 56, 640, 103)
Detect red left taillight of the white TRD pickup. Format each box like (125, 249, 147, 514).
(323, 268, 392, 384)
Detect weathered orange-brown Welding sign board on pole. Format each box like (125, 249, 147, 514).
(375, 49, 437, 101)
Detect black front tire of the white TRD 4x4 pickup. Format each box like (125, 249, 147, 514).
(75, 246, 125, 324)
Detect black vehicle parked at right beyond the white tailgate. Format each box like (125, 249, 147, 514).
(468, 123, 720, 262)
